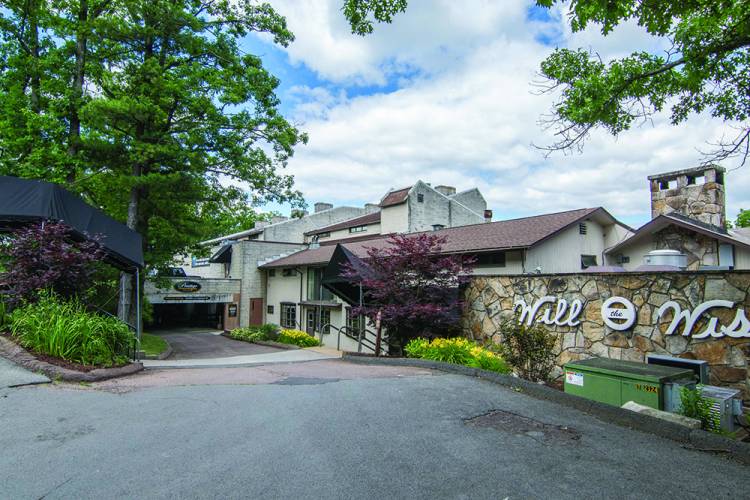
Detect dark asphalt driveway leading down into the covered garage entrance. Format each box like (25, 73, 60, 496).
(151, 328, 283, 359)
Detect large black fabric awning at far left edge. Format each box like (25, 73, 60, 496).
(0, 176, 143, 269)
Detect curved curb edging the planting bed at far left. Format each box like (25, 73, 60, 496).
(0, 337, 143, 382)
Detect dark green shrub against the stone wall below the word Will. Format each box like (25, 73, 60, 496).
(496, 319, 555, 381)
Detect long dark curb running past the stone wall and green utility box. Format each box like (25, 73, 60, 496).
(341, 353, 750, 465)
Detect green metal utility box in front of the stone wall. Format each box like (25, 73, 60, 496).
(564, 358, 695, 410)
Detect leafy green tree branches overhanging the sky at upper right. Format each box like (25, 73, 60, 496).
(537, 0, 750, 162)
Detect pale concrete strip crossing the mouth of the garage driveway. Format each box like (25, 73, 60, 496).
(143, 347, 341, 368)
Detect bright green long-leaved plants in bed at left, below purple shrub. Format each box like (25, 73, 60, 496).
(10, 292, 134, 366)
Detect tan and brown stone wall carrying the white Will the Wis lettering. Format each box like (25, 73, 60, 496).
(463, 271, 750, 399)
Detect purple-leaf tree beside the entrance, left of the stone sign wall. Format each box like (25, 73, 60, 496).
(343, 233, 474, 349)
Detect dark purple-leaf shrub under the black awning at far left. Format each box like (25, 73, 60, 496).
(0, 222, 104, 303)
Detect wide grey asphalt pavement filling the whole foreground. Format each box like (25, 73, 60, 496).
(0, 360, 750, 499)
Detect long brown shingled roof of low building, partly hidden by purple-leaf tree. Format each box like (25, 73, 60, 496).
(261, 208, 615, 268)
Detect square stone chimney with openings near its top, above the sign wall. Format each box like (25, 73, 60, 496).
(648, 165, 727, 229)
